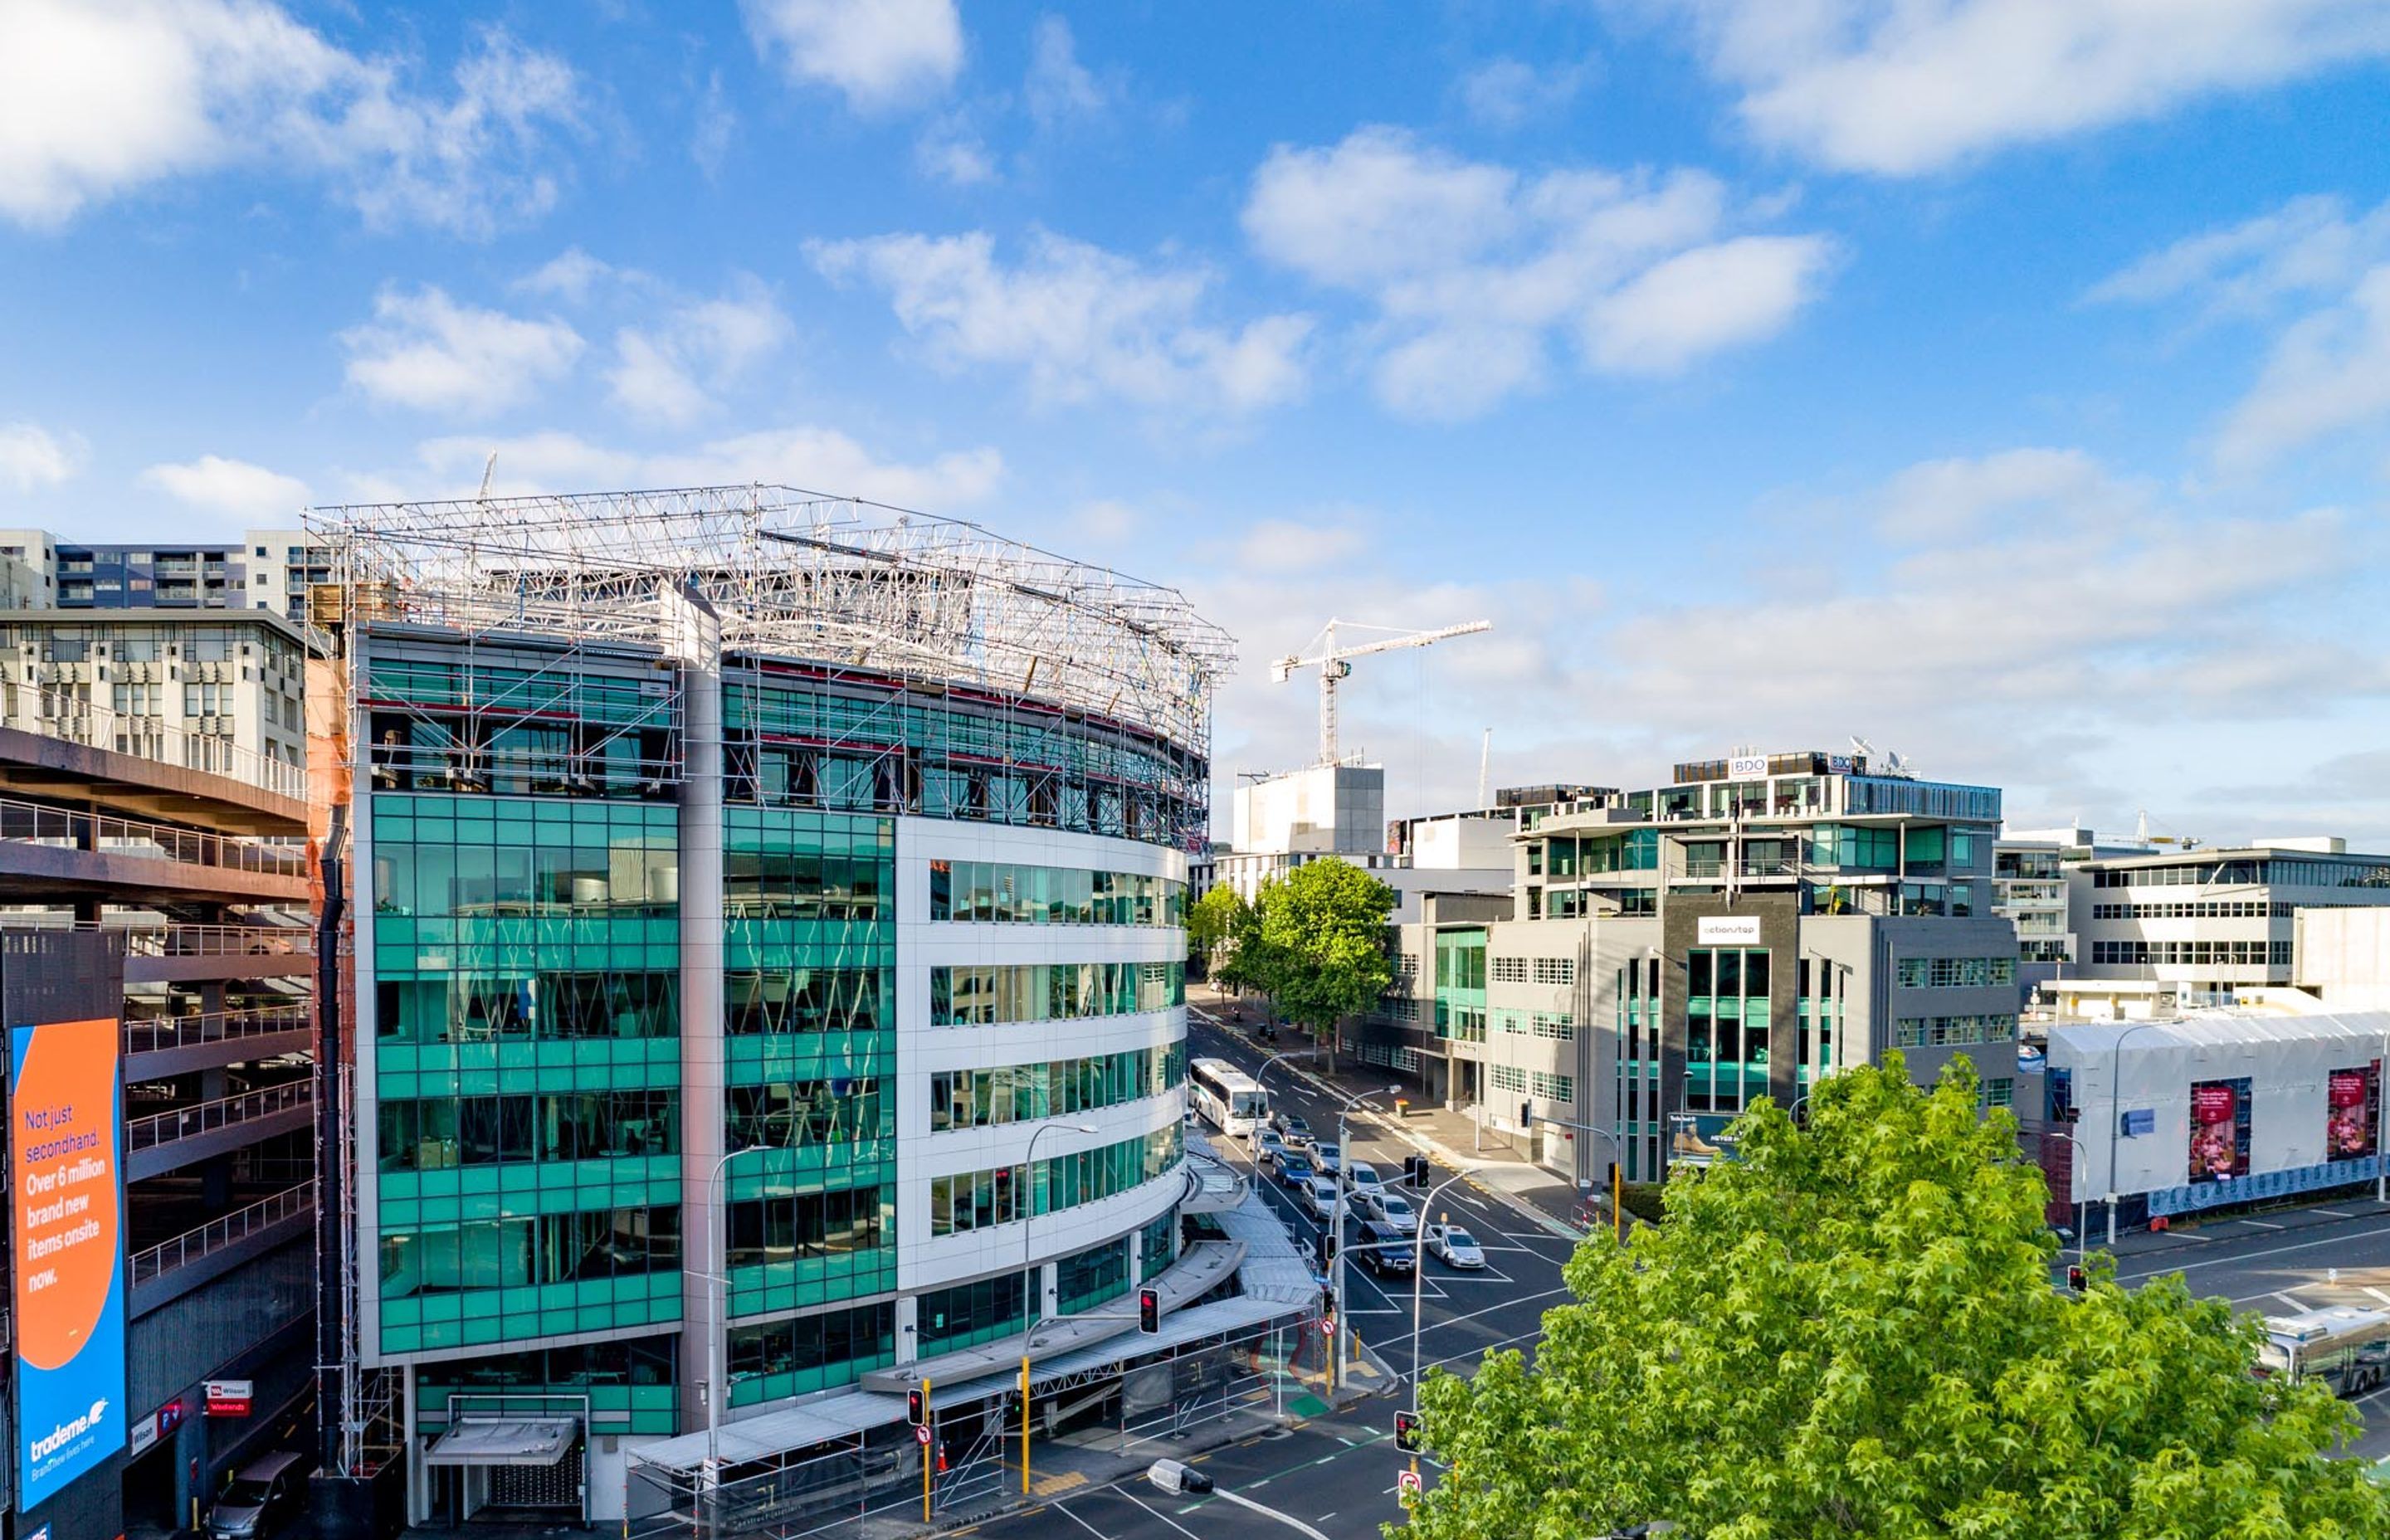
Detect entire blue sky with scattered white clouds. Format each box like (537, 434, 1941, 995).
(0, 0, 2390, 846)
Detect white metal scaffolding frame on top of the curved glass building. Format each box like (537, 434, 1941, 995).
(306, 485, 1236, 748)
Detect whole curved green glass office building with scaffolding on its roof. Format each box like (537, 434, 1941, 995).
(318, 488, 1231, 1521)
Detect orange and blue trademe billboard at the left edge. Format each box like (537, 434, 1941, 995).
(10, 1019, 127, 1511)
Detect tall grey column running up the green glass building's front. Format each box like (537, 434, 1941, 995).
(657, 593, 736, 1430)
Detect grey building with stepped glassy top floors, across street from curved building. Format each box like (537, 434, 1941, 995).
(1363, 753, 2017, 1182)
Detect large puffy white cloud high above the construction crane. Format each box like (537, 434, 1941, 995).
(1243, 127, 1833, 418)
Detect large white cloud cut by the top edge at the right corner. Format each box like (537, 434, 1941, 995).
(1646, 0, 2390, 177)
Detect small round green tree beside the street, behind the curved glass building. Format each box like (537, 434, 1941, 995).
(1255, 856, 1393, 1074)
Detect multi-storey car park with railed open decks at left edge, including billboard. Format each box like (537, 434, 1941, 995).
(0, 655, 315, 1535)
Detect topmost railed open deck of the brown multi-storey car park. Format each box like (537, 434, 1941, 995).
(0, 799, 309, 904)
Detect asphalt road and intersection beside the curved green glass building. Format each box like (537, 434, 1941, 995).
(975, 1011, 1573, 1540)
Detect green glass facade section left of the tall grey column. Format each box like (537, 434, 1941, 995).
(370, 794, 681, 1353)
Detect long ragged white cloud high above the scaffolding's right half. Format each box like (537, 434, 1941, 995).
(810, 232, 1312, 416)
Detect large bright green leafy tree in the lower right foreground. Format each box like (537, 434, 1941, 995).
(1386, 1055, 2390, 1540)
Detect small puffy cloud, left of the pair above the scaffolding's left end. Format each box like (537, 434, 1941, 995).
(339, 287, 583, 414)
